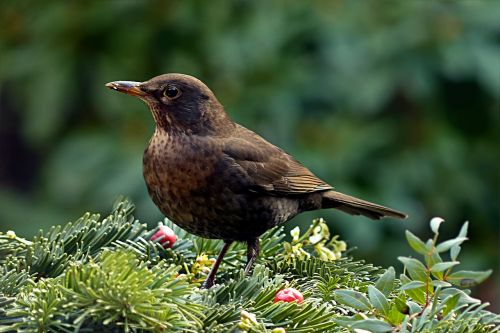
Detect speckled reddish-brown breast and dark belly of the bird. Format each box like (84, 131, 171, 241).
(143, 129, 298, 240)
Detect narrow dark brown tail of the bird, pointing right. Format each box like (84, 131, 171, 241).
(322, 191, 408, 220)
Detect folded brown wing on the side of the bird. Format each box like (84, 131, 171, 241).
(222, 132, 333, 195)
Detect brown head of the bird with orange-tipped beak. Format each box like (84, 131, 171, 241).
(106, 74, 230, 135)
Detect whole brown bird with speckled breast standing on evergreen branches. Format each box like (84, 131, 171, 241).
(106, 74, 406, 288)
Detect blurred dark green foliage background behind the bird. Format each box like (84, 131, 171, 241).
(0, 0, 500, 310)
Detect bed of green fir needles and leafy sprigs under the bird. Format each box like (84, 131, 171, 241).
(0, 201, 500, 333)
